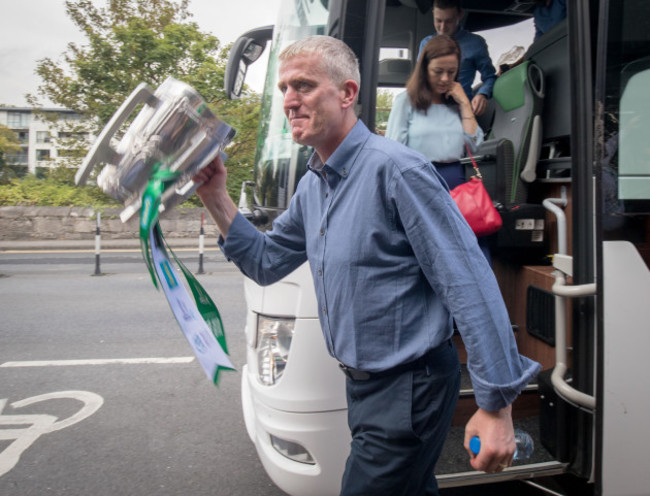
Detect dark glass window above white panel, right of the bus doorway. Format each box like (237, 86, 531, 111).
(599, 2, 650, 266)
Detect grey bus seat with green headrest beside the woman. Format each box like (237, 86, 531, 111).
(468, 61, 544, 203)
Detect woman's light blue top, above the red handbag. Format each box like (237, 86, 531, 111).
(386, 91, 484, 162)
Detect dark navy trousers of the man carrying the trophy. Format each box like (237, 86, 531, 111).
(341, 341, 460, 496)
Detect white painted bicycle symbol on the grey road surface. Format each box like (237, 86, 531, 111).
(0, 391, 104, 477)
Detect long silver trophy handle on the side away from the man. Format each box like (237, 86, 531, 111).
(74, 83, 158, 185)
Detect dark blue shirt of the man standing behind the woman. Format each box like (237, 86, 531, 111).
(418, 29, 497, 100)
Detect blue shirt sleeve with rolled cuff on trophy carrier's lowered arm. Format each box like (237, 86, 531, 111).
(393, 163, 541, 411)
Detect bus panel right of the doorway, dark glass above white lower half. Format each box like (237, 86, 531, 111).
(594, 1, 650, 496)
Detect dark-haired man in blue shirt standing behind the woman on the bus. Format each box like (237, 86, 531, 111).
(418, 0, 497, 115)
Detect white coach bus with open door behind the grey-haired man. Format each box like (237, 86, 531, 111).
(226, 0, 650, 496)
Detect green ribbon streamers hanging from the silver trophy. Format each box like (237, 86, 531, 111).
(140, 163, 233, 385)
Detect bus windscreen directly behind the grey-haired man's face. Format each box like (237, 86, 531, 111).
(255, 0, 329, 210)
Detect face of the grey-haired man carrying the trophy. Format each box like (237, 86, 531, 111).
(278, 54, 345, 156)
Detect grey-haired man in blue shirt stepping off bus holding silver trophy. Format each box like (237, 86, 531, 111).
(194, 36, 539, 496)
